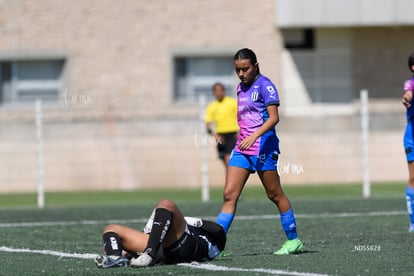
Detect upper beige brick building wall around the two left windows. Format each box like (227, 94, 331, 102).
(0, 0, 280, 118)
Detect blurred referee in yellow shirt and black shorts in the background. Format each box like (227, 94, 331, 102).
(205, 83, 239, 170)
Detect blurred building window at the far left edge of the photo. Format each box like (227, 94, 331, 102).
(0, 59, 64, 104)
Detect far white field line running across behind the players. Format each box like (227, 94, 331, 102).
(0, 211, 407, 228)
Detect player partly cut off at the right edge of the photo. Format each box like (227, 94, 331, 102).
(402, 53, 414, 233)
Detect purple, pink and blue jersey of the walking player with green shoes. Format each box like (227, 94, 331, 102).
(234, 75, 279, 156)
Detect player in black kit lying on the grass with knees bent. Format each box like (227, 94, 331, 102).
(95, 199, 226, 268)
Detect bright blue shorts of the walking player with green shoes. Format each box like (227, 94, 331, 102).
(229, 150, 279, 173)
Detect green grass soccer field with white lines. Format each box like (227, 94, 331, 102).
(0, 184, 414, 275)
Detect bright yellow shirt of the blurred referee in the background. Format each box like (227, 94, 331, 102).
(205, 96, 239, 134)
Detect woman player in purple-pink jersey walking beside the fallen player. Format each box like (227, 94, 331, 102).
(216, 48, 303, 255)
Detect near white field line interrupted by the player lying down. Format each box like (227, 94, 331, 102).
(0, 246, 326, 276)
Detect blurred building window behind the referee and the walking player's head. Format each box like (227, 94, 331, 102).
(174, 56, 237, 103)
